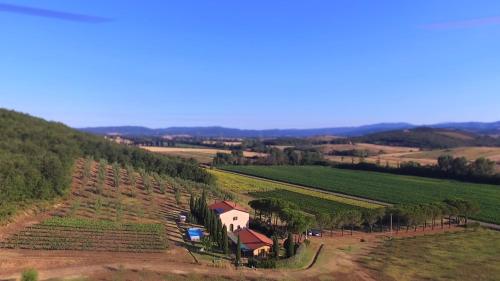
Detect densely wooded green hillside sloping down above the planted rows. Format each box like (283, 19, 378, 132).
(0, 109, 212, 220)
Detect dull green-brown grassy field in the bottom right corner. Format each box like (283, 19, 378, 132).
(360, 230, 500, 281)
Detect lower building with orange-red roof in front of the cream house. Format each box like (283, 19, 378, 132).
(228, 228, 273, 256)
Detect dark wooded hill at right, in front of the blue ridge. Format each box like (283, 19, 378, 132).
(353, 127, 500, 149)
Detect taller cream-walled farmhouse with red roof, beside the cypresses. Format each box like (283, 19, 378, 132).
(208, 201, 250, 232)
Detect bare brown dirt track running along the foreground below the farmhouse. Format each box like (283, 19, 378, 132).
(0, 227, 460, 281)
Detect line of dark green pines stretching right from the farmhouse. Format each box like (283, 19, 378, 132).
(249, 199, 480, 238)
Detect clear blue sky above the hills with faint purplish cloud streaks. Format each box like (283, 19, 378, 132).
(0, 0, 500, 129)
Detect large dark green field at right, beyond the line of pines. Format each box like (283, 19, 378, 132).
(223, 166, 500, 223)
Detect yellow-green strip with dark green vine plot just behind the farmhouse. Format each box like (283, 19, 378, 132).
(209, 170, 381, 213)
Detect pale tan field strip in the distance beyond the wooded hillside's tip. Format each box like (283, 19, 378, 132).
(141, 146, 265, 163)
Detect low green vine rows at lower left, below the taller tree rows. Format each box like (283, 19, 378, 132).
(0, 218, 167, 252)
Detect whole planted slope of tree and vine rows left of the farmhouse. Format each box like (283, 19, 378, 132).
(0, 159, 193, 252)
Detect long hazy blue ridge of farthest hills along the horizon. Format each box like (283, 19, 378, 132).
(79, 121, 500, 138)
